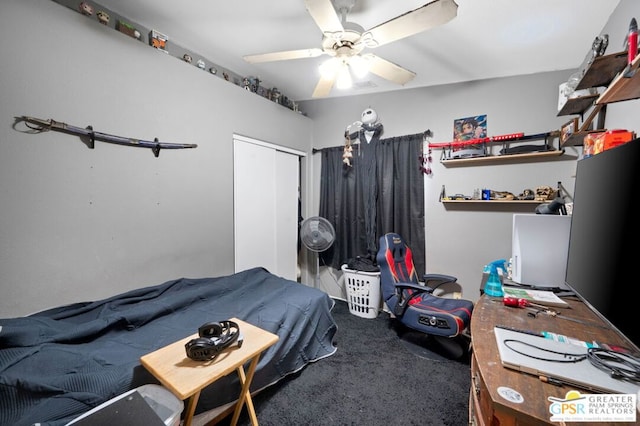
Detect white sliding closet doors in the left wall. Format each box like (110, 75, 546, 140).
(233, 135, 304, 281)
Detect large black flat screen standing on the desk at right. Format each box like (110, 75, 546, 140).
(565, 139, 640, 350)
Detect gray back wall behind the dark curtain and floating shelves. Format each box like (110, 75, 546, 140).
(301, 0, 640, 300)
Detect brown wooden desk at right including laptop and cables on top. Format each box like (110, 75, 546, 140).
(469, 294, 640, 425)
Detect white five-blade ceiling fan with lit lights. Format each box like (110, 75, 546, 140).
(243, 0, 458, 98)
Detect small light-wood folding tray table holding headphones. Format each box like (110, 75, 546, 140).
(140, 318, 278, 426)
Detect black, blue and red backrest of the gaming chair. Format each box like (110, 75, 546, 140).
(376, 232, 418, 311)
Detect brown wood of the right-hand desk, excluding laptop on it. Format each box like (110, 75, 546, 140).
(469, 295, 640, 426)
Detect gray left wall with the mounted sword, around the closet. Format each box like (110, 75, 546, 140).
(0, 0, 311, 317)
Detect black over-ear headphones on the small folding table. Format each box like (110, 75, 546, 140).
(184, 321, 242, 361)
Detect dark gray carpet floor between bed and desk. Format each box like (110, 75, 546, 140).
(221, 301, 471, 426)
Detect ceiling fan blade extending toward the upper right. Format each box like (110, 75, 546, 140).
(363, 0, 458, 47)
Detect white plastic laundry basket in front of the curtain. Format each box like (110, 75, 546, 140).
(342, 265, 382, 319)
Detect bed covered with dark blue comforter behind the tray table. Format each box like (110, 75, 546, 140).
(0, 268, 336, 426)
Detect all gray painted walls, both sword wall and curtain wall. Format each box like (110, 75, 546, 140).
(0, 0, 639, 317)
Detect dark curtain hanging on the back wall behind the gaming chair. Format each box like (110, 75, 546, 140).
(319, 131, 425, 276)
